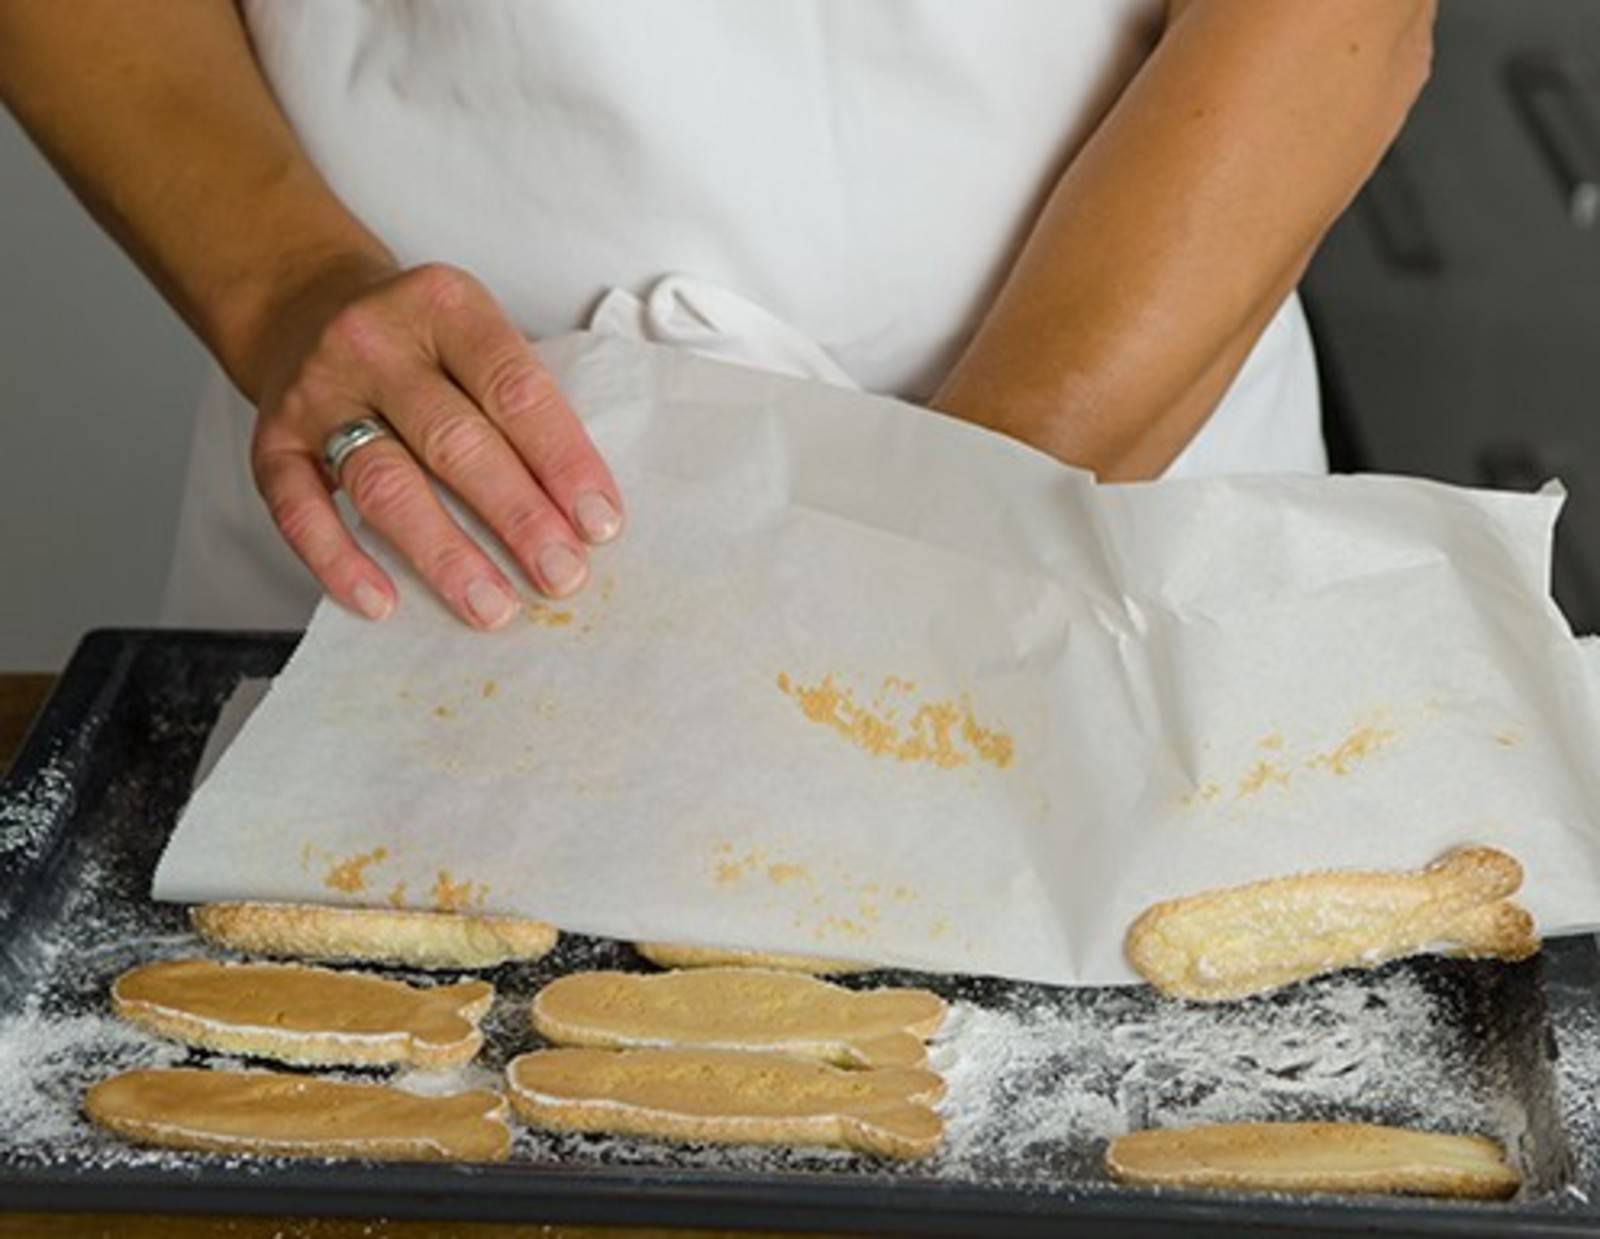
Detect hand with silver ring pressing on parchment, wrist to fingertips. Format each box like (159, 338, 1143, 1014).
(251, 263, 622, 629)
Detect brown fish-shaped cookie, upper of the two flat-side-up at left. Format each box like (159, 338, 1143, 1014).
(110, 959, 494, 1069)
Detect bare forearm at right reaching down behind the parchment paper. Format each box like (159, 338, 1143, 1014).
(934, 0, 1432, 479)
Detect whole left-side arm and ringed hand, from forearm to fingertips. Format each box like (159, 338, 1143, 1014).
(0, 0, 622, 628)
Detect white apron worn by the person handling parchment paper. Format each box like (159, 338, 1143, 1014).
(163, 0, 1326, 628)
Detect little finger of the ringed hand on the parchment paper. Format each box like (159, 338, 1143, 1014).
(254, 447, 395, 620)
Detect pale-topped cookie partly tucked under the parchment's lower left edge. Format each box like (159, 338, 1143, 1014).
(189, 903, 555, 968)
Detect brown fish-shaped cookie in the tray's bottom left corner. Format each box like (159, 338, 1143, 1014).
(83, 1068, 510, 1162)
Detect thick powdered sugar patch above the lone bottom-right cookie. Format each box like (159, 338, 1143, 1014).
(933, 973, 1526, 1180)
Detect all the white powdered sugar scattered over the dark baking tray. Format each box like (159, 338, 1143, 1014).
(0, 717, 1574, 1201)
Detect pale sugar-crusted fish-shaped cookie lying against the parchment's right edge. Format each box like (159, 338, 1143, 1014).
(1126, 847, 1539, 1002)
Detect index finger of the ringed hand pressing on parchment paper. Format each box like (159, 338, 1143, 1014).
(419, 267, 622, 543)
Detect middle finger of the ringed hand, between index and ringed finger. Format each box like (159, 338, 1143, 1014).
(379, 367, 587, 597)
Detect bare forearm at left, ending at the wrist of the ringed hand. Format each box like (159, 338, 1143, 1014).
(0, 0, 390, 395)
